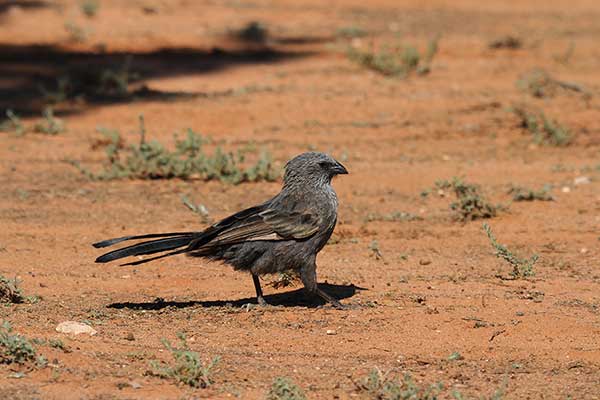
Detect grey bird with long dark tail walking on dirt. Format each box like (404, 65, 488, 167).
(93, 152, 348, 308)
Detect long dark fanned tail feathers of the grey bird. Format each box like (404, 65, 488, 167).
(95, 232, 197, 263)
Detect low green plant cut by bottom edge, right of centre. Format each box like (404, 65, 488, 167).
(355, 368, 443, 400)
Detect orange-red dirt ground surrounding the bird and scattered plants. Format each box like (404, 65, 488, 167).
(0, 0, 600, 399)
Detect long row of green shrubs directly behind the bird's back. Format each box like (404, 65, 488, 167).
(71, 116, 279, 184)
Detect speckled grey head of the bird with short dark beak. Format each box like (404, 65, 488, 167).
(283, 152, 348, 185)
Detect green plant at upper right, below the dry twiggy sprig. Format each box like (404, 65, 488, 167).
(512, 106, 573, 147)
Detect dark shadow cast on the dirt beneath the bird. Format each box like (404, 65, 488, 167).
(107, 283, 366, 310)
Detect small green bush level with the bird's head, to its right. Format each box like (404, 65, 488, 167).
(435, 177, 501, 221)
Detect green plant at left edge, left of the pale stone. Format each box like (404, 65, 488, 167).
(0, 321, 46, 367)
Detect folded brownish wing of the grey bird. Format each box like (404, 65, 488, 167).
(189, 205, 322, 250)
